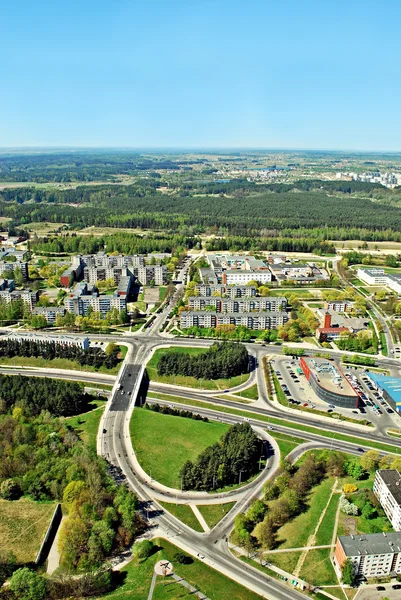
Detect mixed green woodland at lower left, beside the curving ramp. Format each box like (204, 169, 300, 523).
(0, 409, 142, 576)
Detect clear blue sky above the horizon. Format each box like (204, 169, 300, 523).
(0, 0, 401, 151)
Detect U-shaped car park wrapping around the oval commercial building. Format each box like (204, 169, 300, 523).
(271, 356, 400, 432)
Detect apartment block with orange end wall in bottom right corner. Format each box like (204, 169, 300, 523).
(334, 532, 401, 578)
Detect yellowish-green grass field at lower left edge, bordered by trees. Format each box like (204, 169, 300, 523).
(0, 498, 56, 563)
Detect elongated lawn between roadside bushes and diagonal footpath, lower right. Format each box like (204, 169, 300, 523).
(277, 477, 334, 548)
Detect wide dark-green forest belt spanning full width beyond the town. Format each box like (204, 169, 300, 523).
(0, 179, 401, 241)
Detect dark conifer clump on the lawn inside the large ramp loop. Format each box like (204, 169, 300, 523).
(180, 423, 261, 491)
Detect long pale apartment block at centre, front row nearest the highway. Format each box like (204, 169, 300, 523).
(180, 311, 288, 329)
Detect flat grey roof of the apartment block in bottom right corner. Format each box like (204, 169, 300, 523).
(338, 531, 401, 556)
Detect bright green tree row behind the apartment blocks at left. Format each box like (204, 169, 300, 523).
(29, 232, 200, 255)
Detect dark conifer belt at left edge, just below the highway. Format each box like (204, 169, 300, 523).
(0, 375, 93, 417)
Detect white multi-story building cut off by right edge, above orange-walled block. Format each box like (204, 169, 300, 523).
(373, 469, 401, 531)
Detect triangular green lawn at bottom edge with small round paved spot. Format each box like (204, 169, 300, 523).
(98, 539, 260, 600)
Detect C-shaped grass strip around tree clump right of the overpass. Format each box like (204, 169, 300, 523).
(146, 346, 249, 390)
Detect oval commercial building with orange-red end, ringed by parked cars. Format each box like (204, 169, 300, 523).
(300, 357, 359, 408)
